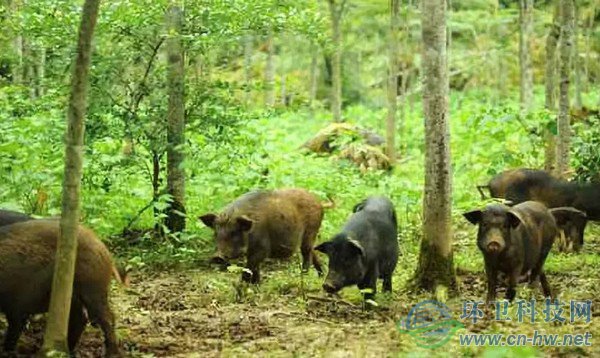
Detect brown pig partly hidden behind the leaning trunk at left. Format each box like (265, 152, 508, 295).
(0, 220, 121, 357)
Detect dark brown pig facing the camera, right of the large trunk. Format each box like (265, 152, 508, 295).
(463, 201, 558, 303)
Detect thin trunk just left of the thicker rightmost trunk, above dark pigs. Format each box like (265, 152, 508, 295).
(544, 5, 560, 172)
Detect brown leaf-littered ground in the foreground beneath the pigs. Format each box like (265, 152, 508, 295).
(0, 226, 600, 357)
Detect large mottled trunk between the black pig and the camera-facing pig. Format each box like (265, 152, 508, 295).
(416, 0, 456, 291)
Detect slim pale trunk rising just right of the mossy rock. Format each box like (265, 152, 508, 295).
(386, 0, 404, 164)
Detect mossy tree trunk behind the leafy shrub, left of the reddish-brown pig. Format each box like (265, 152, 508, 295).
(165, 0, 185, 233)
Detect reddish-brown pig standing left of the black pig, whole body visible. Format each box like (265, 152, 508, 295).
(199, 189, 323, 283)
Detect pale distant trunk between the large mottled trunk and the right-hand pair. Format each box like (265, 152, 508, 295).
(519, 0, 533, 111)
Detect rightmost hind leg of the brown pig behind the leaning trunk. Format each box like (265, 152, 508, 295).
(82, 287, 121, 357)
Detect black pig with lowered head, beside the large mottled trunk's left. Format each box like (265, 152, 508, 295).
(315, 196, 398, 300)
